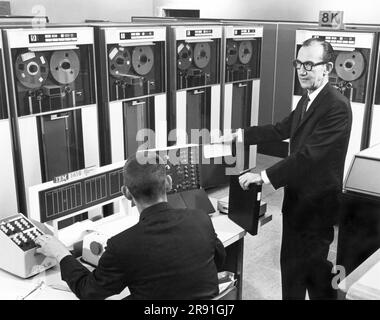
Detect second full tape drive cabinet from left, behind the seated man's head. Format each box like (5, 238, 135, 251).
(95, 24, 167, 164)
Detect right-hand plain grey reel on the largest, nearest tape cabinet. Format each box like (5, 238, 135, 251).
(50, 50, 80, 84)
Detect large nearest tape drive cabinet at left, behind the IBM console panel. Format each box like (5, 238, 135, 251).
(4, 27, 99, 214)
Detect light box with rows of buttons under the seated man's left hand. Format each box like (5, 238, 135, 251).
(0, 213, 56, 278)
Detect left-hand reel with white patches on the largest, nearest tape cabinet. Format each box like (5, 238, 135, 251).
(15, 51, 49, 89)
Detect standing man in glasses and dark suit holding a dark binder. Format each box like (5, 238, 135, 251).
(223, 38, 352, 299)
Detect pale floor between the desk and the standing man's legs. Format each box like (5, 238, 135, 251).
(243, 154, 337, 300)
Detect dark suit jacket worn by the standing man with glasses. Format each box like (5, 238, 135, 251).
(244, 84, 352, 229)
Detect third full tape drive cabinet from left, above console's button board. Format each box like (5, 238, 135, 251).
(168, 23, 222, 145)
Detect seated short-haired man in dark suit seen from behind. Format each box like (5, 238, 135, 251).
(36, 153, 225, 299)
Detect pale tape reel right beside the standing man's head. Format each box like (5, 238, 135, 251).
(335, 50, 365, 81)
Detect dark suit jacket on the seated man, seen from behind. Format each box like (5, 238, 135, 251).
(60, 202, 225, 299)
